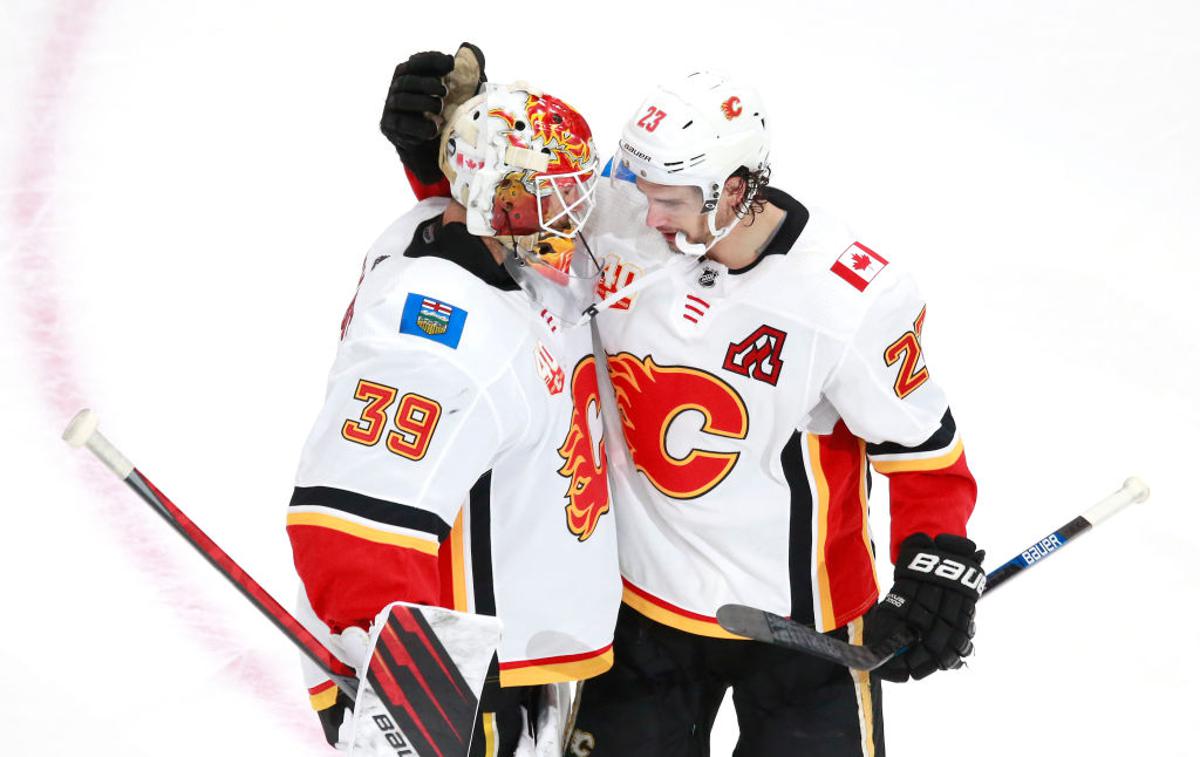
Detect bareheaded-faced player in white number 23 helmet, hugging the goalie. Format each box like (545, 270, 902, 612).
(384, 48, 983, 756)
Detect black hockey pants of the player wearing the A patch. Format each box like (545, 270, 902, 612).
(568, 606, 883, 757)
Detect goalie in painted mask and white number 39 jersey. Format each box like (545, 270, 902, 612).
(288, 78, 620, 757)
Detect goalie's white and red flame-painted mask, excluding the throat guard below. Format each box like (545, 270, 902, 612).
(439, 83, 600, 242)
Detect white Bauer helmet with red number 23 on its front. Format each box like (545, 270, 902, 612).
(613, 72, 770, 254)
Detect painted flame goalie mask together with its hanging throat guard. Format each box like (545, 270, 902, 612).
(440, 83, 600, 323)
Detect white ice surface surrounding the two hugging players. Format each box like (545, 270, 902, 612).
(0, 0, 1200, 757)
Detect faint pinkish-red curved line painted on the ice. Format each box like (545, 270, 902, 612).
(8, 0, 313, 729)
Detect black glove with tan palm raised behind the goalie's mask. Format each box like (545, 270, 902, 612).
(379, 42, 487, 184)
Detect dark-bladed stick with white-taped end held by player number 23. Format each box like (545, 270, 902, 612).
(716, 477, 1150, 671)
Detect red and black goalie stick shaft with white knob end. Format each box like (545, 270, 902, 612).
(62, 410, 359, 701)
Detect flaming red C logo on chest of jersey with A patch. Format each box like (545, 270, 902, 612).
(608, 353, 750, 499)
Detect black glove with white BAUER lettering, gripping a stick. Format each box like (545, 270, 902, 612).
(864, 534, 985, 683)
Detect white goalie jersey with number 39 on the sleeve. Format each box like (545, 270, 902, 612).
(288, 199, 622, 693)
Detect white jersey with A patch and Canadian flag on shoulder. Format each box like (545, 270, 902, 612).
(589, 182, 974, 637)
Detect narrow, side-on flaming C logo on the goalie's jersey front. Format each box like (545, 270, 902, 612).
(558, 355, 610, 541)
